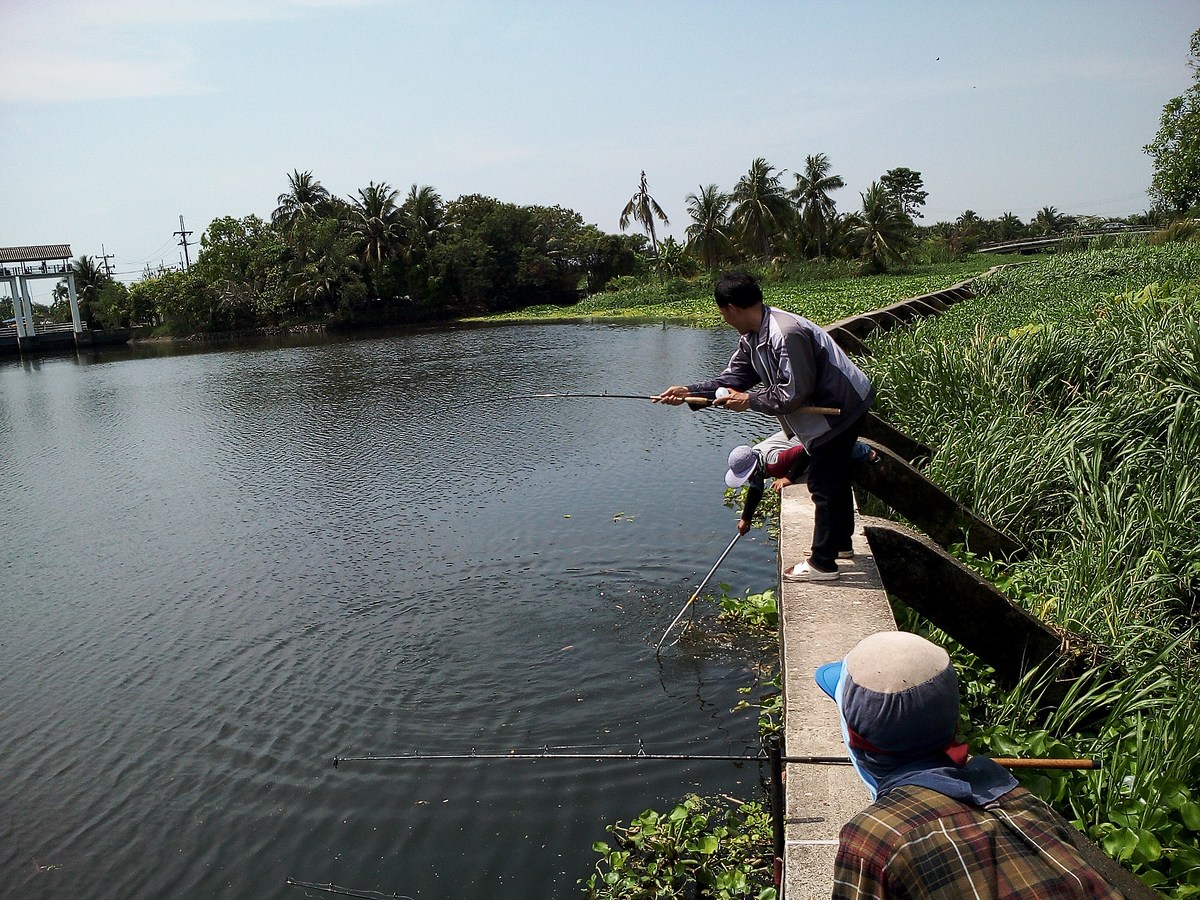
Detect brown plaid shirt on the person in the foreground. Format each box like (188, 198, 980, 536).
(833, 785, 1122, 900)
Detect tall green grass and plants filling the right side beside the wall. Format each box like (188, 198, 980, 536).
(866, 244, 1200, 896)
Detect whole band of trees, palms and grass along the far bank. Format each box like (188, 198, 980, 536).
(14, 154, 1171, 336)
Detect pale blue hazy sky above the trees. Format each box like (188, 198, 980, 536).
(0, 0, 1200, 293)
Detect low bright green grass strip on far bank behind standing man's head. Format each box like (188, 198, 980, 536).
(484, 254, 1014, 328)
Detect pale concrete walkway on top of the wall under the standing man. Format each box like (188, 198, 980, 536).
(778, 484, 895, 900)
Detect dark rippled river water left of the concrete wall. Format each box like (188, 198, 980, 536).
(0, 325, 775, 898)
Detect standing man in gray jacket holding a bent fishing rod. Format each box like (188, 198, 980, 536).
(653, 272, 875, 581)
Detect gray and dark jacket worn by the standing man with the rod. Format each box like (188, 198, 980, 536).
(688, 305, 875, 450)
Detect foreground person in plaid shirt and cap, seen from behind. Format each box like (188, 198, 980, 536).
(816, 631, 1124, 900)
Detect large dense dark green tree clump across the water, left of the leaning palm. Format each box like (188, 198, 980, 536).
(87, 170, 646, 334)
